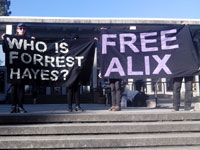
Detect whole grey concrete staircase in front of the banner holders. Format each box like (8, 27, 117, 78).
(0, 106, 200, 150)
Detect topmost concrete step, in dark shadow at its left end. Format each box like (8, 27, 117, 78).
(0, 111, 200, 124)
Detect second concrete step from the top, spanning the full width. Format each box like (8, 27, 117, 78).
(0, 121, 200, 136)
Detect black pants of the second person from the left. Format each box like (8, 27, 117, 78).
(67, 85, 80, 108)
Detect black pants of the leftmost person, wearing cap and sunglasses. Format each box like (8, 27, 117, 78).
(11, 84, 24, 107)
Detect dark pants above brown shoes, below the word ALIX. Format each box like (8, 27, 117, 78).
(110, 79, 121, 106)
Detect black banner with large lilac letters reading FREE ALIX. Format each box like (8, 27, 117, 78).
(100, 26, 198, 79)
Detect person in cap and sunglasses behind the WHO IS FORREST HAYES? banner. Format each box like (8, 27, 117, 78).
(1, 23, 35, 113)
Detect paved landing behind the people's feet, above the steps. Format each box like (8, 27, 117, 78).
(0, 99, 197, 114)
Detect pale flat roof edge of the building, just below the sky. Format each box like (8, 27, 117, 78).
(0, 16, 200, 25)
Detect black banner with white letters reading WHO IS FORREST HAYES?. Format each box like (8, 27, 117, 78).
(3, 35, 95, 87)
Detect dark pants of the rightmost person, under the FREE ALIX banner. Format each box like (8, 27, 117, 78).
(173, 76, 193, 110)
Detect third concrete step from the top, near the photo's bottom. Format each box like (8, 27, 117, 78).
(0, 133, 200, 149)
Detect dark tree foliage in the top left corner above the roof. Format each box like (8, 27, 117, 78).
(0, 0, 11, 16)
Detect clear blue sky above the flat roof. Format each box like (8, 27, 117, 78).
(0, 0, 200, 65)
